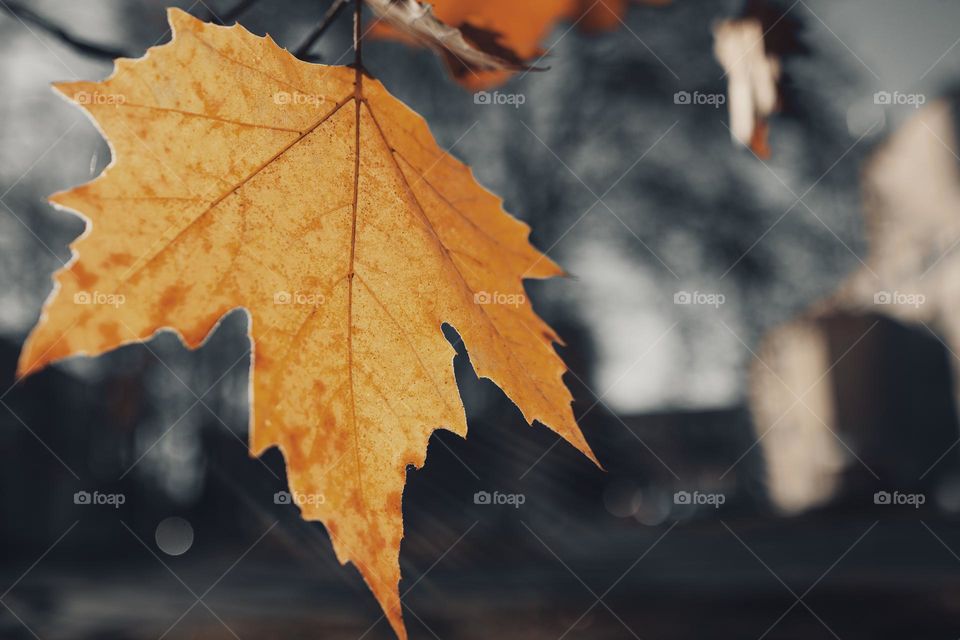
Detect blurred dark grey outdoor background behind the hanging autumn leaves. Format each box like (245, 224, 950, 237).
(0, 0, 960, 640)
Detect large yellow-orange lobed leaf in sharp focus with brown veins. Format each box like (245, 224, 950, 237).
(19, 9, 595, 638)
